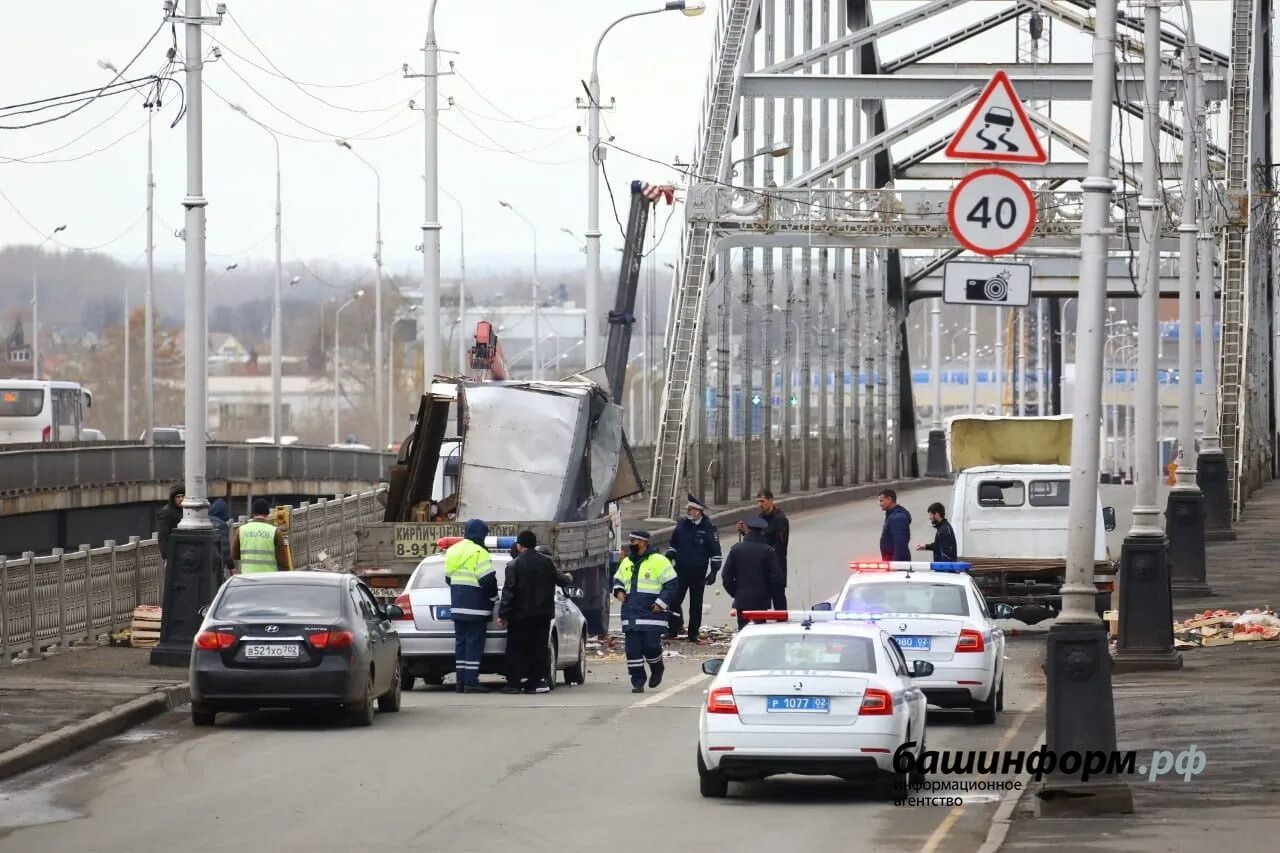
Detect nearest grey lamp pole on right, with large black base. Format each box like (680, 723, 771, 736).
(1038, 0, 1131, 816)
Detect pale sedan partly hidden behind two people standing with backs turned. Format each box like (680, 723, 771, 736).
(392, 551, 586, 690)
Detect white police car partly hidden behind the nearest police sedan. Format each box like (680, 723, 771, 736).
(833, 561, 1005, 724)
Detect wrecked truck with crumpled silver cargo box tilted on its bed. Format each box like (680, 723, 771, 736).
(355, 371, 641, 637)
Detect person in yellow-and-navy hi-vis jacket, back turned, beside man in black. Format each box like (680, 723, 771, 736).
(444, 519, 498, 693)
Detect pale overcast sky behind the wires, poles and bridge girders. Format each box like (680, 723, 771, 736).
(0, 0, 1230, 274)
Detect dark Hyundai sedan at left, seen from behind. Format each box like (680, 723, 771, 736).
(191, 571, 401, 726)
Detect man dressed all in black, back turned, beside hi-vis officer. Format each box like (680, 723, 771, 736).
(498, 530, 573, 693)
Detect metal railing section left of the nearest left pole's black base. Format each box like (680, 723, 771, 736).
(0, 537, 164, 665)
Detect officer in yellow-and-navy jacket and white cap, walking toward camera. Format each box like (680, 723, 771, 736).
(613, 530, 680, 693)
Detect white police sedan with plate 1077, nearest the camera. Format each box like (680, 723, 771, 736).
(698, 611, 933, 797)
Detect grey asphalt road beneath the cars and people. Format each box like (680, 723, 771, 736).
(0, 487, 1146, 853)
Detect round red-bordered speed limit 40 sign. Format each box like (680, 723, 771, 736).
(947, 168, 1036, 257)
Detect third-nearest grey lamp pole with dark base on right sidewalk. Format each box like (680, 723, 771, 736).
(1165, 19, 1212, 597)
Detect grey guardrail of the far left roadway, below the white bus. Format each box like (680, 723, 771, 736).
(0, 442, 393, 494)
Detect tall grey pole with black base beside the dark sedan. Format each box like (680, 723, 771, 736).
(151, 0, 223, 666)
